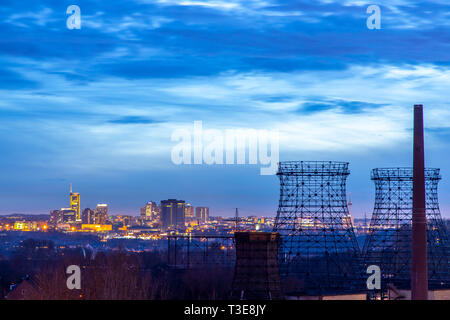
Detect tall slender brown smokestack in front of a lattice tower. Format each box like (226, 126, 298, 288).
(411, 104, 428, 300)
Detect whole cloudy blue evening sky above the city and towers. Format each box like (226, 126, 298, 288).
(0, 0, 450, 217)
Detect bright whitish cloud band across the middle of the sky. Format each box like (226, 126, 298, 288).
(2, 61, 450, 174)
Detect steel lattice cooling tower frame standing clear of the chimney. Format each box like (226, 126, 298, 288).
(274, 161, 364, 294)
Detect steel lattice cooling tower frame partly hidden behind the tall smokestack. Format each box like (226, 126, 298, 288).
(364, 168, 450, 289)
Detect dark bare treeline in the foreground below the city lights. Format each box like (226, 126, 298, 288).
(0, 239, 233, 300)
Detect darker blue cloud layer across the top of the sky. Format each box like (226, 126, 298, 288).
(0, 0, 450, 81)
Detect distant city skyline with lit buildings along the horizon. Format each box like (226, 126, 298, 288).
(0, 182, 412, 240)
